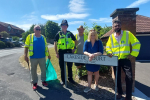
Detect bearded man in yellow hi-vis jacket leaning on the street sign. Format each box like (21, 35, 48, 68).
(106, 20, 141, 100)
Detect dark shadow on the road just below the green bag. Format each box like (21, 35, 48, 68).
(37, 80, 73, 100)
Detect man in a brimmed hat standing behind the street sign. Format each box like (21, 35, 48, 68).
(74, 25, 87, 78)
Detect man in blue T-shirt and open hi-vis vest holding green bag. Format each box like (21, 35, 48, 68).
(24, 25, 51, 90)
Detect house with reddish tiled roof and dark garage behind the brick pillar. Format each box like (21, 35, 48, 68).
(101, 15, 150, 61)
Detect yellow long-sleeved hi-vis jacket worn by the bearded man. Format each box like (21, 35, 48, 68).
(106, 31, 141, 59)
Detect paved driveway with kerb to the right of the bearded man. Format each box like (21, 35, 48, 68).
(133, 61, 150, 100)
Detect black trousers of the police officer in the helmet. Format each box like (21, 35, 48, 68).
(59, 49, 73, 82)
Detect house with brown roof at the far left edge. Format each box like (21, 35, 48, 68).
(0, 22, 25, 37)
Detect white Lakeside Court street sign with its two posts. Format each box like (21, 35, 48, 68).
(64, 53, 118, 100)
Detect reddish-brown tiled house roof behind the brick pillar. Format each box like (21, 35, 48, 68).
(101, 15, 150, 38)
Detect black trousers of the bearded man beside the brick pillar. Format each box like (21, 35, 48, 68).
(114, 59, 133, 100)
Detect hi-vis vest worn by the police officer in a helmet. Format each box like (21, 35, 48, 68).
(57, 32, 74, 50)
